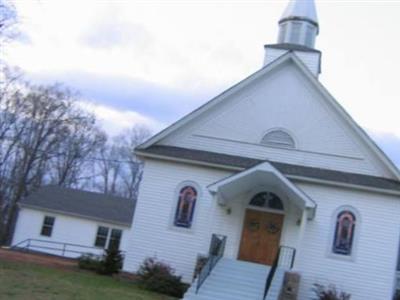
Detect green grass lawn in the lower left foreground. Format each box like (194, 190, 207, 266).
(0, 260, 176, 300)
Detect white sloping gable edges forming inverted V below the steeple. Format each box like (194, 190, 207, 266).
(137, 51, 400, 180)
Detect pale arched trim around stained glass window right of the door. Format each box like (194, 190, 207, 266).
(328, 205, 362, 261)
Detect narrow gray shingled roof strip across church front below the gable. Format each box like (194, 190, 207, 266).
(139, 146, 400, 191)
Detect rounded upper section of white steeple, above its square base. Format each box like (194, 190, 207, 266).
(278, 0, 318, 48)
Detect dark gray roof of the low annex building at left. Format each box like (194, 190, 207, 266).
(20, 186, 135, 226)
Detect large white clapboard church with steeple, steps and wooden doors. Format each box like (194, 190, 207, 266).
(124, 0, 400, 300)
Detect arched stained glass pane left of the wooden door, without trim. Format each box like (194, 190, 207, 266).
(174, 186, 197, 228)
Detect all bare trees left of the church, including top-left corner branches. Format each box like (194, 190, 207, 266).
(0, 0, 150, 244)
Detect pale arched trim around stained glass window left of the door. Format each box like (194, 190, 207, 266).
(169, 180, 202, 233)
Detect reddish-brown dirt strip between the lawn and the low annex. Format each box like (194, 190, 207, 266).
(0, 248, 78, 269)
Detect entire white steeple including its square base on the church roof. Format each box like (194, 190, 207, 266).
(264, 0, 321, 77)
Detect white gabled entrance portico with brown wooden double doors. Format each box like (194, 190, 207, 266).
(208, 162, 316, 265)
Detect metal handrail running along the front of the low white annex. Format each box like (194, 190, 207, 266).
(11, 239, 119, 257)
